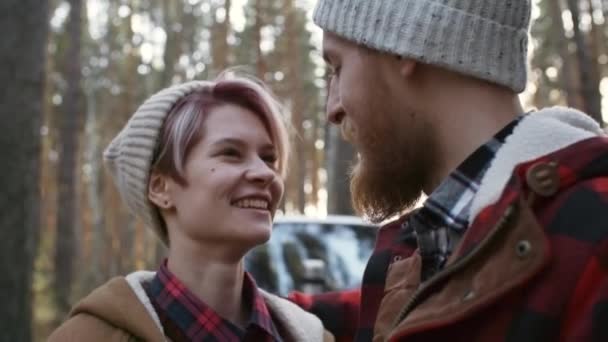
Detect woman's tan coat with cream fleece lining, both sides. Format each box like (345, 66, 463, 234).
(48, 271, 334, 342)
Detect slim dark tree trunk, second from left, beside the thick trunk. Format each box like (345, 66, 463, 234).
(55, 0, 82, 320)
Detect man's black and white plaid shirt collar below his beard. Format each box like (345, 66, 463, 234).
(414, 116, 523, 281)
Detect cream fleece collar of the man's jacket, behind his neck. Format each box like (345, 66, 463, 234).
(469, 107, 606, 222)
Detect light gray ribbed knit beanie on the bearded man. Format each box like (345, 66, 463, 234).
(314, 0, 531, 93)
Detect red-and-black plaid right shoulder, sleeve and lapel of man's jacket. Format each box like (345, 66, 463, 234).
(392, 137, 608, 342)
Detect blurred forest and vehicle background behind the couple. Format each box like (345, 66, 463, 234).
(0, 0, 608, 341)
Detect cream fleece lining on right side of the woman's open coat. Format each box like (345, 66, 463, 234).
(259, 289, 334, 341)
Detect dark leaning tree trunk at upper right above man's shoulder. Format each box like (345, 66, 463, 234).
(568, 0, 604, 126)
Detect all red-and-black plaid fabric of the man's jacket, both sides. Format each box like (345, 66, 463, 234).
(290, 138, 608, 342)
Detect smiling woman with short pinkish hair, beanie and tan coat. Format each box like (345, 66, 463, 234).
(50, 76, 332, 341)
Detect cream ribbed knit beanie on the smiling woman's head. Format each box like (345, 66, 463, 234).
(103, 81, 212, 245)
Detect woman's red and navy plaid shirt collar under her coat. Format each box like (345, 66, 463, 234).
(145, 260, 282, 342)
